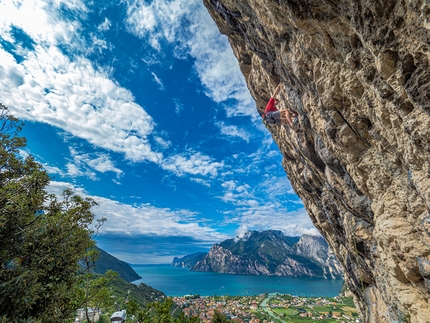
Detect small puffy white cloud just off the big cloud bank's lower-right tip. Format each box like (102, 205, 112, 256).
(161, 152, 224, 177)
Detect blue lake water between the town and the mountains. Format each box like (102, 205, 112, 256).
(131, 265, 343, 297)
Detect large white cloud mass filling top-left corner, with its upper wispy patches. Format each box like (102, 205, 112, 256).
(0, 0, 161, 162)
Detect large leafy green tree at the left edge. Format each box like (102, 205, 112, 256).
(0, 104, 96, 322)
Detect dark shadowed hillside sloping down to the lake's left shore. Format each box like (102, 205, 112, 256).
(80, 247, 142, 282)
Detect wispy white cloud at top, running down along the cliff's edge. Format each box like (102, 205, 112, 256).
(127, 0, 258, 118)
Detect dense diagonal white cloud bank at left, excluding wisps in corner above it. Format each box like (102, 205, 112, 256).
(0, 46, 161, 162)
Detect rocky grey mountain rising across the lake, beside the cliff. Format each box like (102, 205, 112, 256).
(186, 230, 342, 279)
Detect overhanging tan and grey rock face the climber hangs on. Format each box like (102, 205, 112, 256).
(204, 0, 430, 322)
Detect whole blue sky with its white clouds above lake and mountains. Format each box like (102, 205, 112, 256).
(0, 0, 317, 263)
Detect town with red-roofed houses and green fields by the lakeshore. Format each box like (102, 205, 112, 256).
(173, 293, 362, 323)
